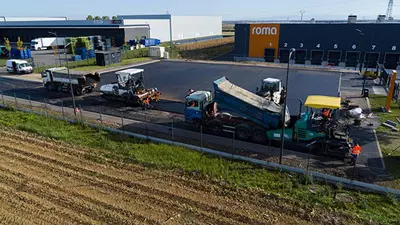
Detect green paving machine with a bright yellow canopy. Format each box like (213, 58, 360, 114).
(267, 95, 352, 159)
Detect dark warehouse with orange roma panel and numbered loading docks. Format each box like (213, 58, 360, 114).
(235, 17, 400, 69)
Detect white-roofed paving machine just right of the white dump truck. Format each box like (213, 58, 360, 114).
(100, 69, 161, 105)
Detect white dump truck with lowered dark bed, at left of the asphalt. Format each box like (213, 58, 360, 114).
(42, 67, 100, 96)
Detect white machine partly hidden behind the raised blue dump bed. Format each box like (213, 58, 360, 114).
(256, 78, 283, 104)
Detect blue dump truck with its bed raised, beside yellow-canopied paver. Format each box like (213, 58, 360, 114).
(184, 77, 290, 142)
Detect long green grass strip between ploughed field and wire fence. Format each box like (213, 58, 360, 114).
(0, 109, 400, 224)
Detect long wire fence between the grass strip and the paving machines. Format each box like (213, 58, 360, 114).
(0, 92, 400, 196)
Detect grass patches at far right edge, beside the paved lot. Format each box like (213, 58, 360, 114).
(370, 95, 400, 189)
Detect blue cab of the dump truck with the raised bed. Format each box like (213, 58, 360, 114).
(185, 91, 213, 127)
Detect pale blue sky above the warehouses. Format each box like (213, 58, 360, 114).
(0, 0, 400, 20)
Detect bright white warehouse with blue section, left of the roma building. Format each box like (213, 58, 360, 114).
(118, 14, 222, 42)
